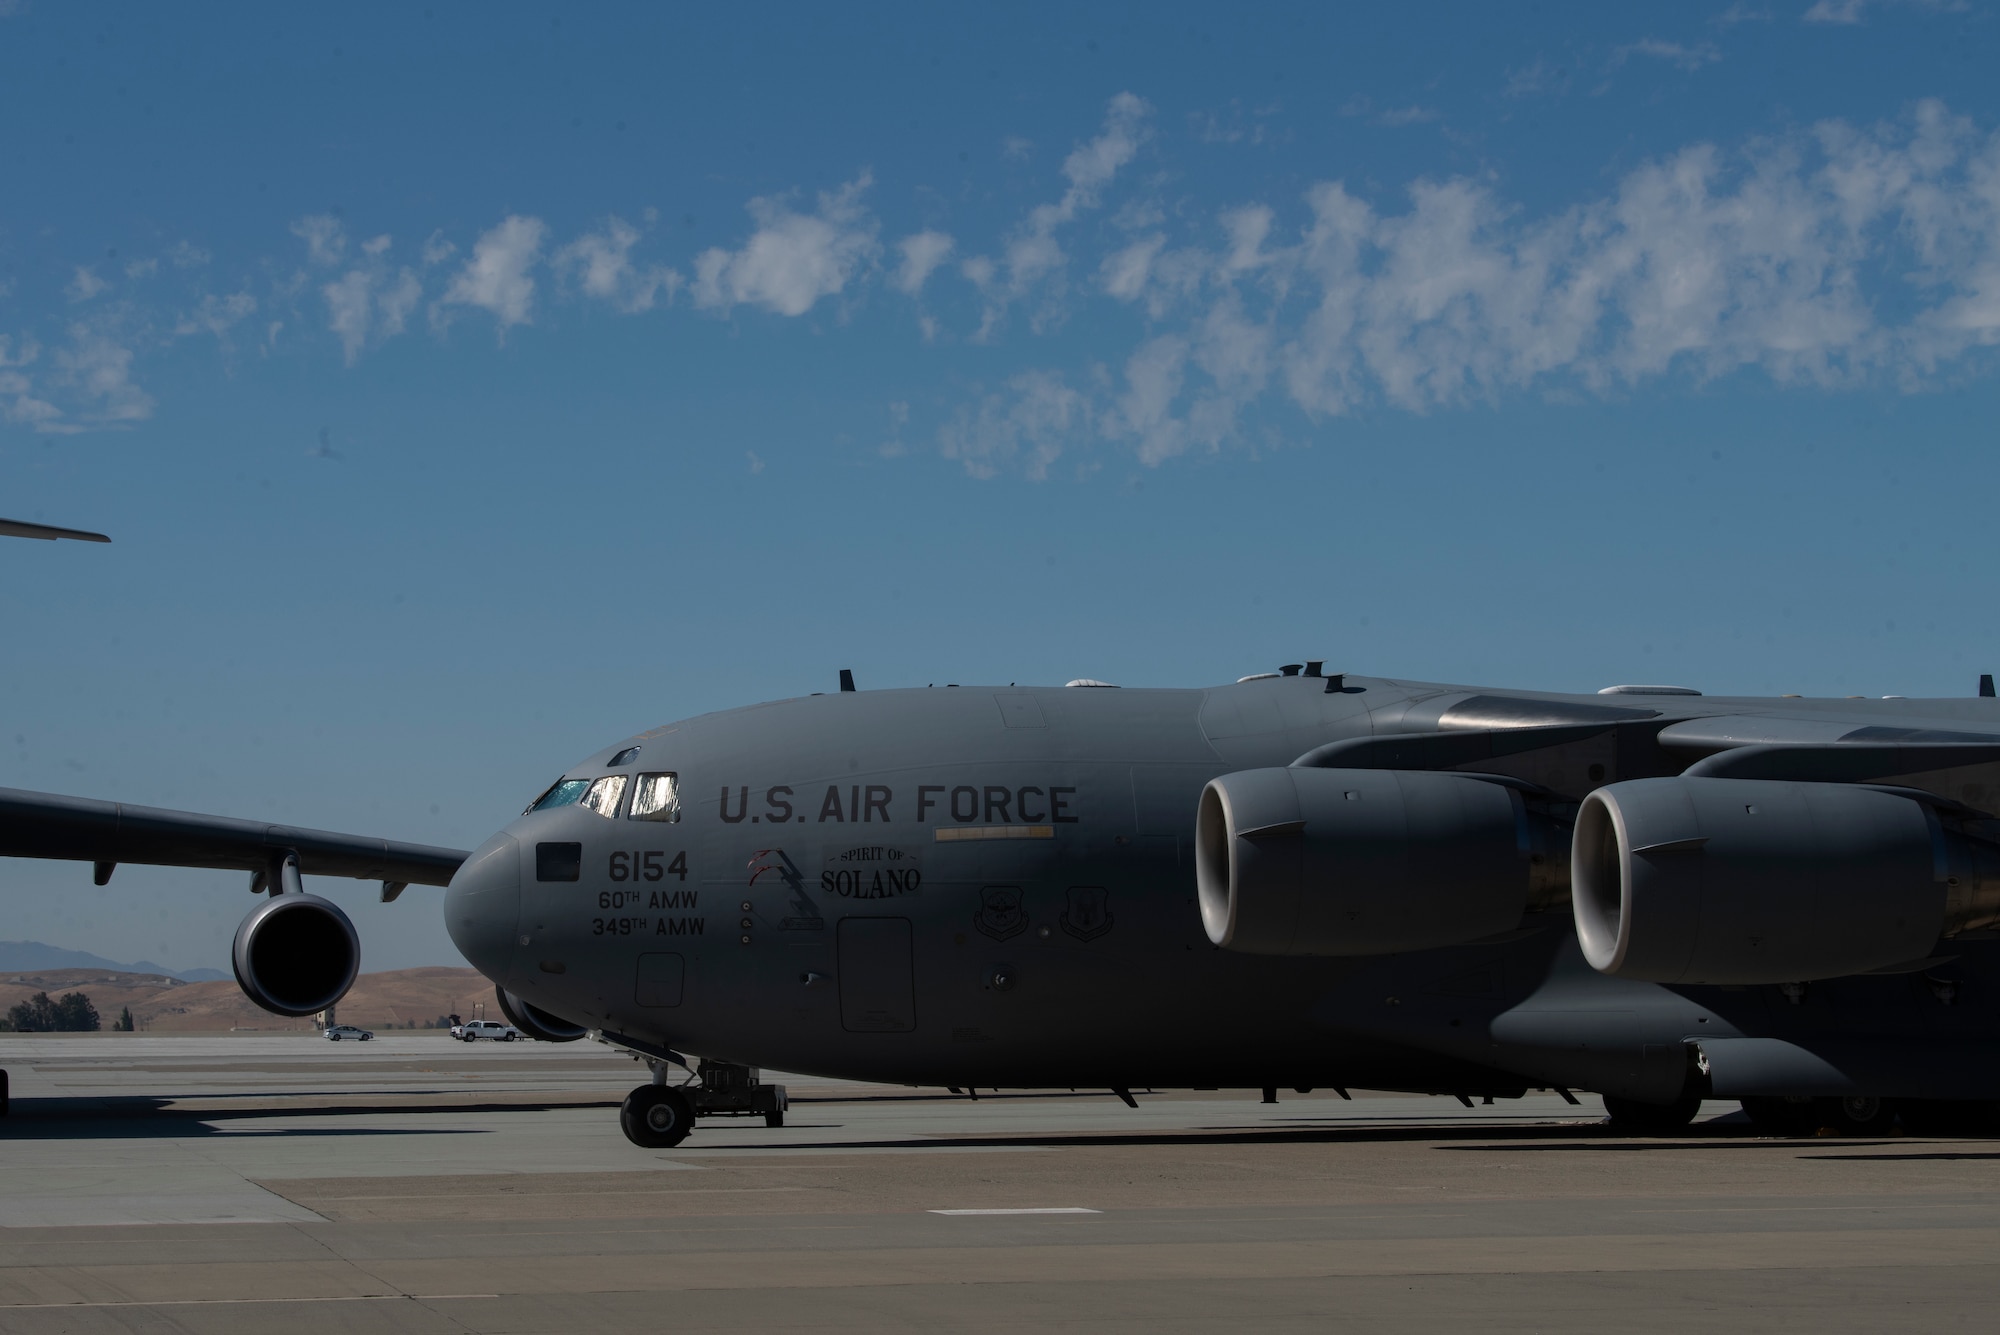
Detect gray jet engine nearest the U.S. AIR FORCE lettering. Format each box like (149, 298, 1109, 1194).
(1194, 767, 1568, 955)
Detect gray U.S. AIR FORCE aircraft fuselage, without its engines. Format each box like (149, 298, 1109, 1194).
(446, 675, 2000, 1099)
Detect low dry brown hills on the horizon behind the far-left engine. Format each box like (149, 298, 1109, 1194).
(0, 965, 500, 1033)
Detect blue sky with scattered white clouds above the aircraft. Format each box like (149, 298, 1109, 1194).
(0, 0, 2000, 967)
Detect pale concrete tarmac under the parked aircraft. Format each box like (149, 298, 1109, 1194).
(0, 1033, 2000, 1335)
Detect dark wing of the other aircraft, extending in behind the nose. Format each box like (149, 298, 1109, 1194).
(0, 787, 466, 897)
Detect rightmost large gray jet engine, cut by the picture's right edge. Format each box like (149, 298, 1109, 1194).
(1570, 777, 2000, 983)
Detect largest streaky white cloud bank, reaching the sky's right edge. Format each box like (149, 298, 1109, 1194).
(940, 102, 2000, 476)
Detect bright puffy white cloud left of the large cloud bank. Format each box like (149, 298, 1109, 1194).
(694, 172, 880, 316)
